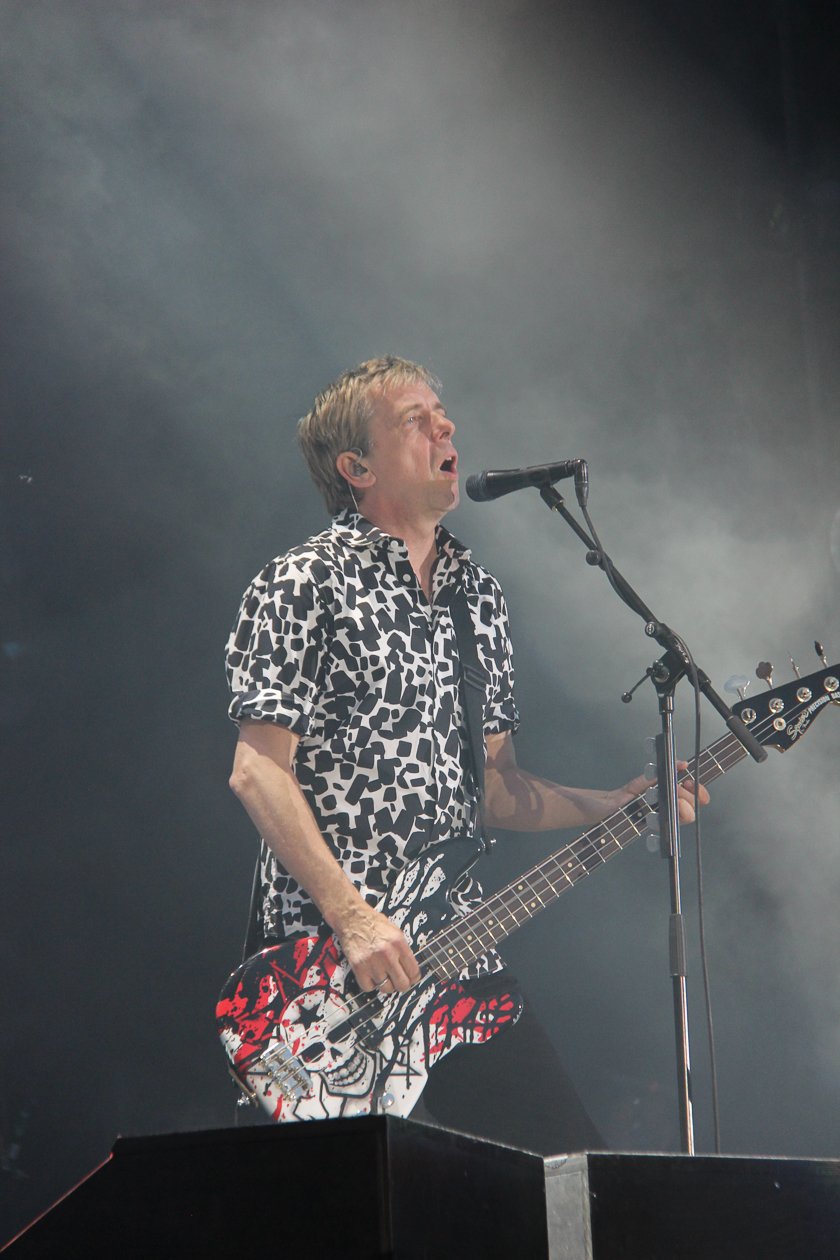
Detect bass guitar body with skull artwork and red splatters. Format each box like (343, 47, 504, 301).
(217, 840, 521, 1123)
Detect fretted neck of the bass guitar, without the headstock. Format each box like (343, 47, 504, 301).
(418, 735, 747, 979)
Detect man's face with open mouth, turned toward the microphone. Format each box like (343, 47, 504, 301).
(363, 381, 458, 523)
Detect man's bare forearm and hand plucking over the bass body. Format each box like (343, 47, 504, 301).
(230, 722, 419, 993)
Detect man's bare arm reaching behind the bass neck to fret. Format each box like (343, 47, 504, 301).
(485, 731, 709, 832)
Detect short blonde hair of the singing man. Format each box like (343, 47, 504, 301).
(297, 354, 441, 515)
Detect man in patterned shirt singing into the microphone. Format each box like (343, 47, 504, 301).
(228, 357, 708, 1153)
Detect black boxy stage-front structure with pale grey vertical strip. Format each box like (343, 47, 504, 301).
(6, 1116, 840, 1260)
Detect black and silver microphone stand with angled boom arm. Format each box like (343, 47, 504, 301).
(539, 479, 767, 1155)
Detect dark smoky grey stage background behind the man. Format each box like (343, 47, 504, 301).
(0, 0, 840, 1236)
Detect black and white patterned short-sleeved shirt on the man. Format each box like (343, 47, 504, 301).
(227, 512, 519, 937)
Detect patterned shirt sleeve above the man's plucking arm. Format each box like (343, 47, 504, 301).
(227, 557, 331, 735)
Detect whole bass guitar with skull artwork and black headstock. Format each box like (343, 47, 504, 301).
(215, 665, 840, 1121)
